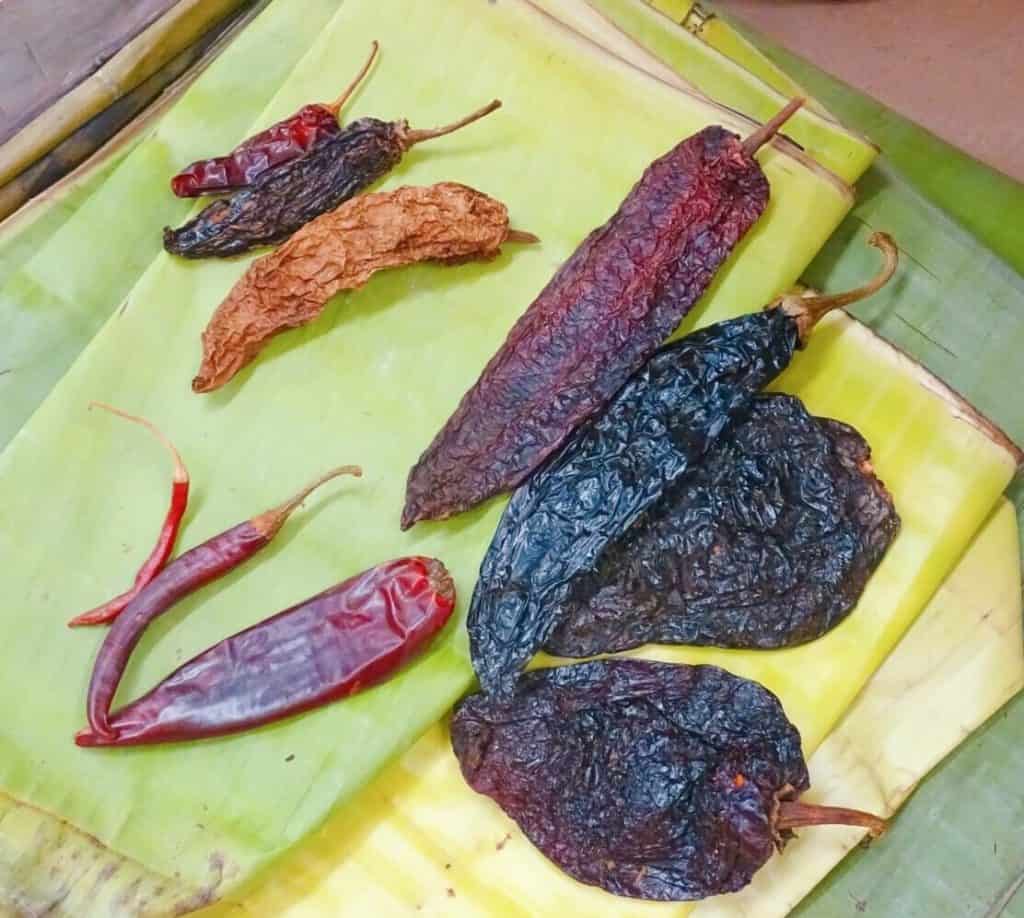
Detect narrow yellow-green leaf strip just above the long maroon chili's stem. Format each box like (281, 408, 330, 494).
(579, 0, 878, 182)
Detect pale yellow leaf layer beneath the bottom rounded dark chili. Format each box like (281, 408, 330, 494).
(193, 501, 1024, 918)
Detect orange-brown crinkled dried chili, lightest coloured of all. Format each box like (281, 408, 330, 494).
(193, 181, 537, 392)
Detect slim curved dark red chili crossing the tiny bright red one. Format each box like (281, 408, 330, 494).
(86, 465, 362, 741)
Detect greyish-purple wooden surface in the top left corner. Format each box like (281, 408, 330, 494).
(0, 0, 174, 143)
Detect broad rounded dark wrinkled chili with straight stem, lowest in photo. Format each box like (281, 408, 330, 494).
(452, 660, 886, 901)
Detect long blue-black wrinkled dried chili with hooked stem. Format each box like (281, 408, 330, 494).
(467, 234, 897, 694)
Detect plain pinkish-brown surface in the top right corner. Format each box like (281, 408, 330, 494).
(717, 0, 1024, 181)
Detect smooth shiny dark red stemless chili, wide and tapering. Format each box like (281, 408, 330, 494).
(75, 556, 455, 746)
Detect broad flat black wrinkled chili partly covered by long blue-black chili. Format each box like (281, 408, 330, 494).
(545, 395, 899, 657)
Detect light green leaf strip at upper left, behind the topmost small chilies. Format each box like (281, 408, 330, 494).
(0, 0, 346, 448)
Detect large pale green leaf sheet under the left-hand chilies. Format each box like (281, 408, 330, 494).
(0, 0, 851, 894)
